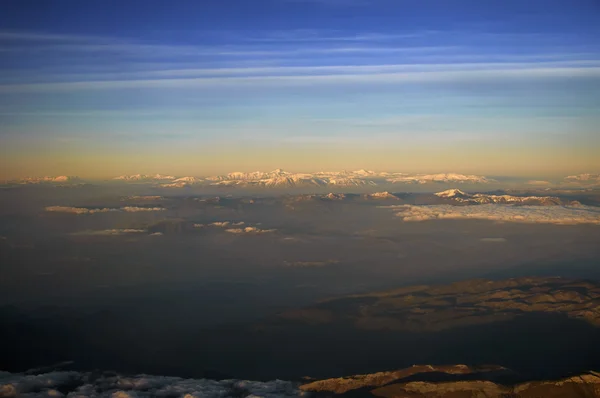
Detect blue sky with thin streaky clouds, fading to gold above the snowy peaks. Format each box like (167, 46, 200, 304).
(0, 0, 600, 178)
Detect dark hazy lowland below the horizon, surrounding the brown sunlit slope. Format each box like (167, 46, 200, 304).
(0, 184, 600, 386)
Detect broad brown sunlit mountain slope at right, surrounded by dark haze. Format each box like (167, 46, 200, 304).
(272, 277, 600, 332)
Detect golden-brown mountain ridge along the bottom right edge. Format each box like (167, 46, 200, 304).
(300, 365, 600, 398)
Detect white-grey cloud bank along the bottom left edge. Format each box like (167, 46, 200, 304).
(0, 372, 309, 398)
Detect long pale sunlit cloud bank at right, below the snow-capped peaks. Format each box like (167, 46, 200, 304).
(386, 204, 600, 225)
